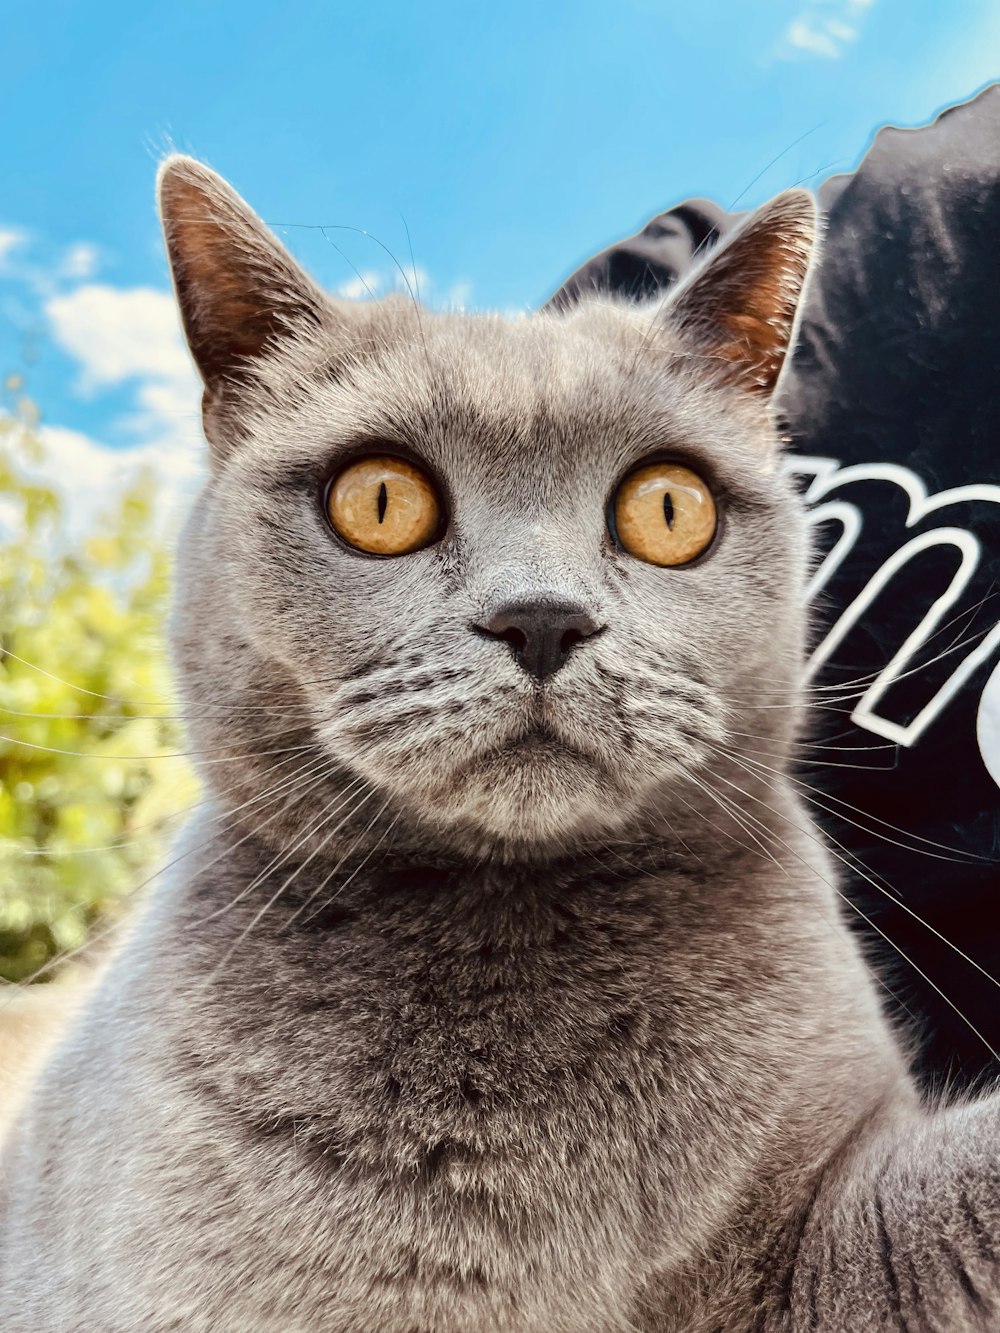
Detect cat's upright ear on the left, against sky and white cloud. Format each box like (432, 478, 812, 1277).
(157, 155, 329, 453)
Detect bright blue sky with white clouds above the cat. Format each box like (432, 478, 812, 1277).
(0, 0, 1000, 495)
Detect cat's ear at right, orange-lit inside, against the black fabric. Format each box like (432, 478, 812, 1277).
(667, 189, 816, 399)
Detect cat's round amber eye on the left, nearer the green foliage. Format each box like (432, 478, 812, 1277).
(327, 456, 441, 556)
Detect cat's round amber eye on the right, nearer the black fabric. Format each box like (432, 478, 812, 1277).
(615, 463, 719, 565)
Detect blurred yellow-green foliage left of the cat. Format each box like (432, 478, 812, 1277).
(0, 380, 197, 981)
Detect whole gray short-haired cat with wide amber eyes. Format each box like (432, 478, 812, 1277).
(0, 157, 1000, 1333)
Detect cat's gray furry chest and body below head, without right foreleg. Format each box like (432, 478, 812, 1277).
(0, 825, 901, 1333)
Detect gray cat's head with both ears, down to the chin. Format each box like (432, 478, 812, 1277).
(160, 157, 815, 856)
